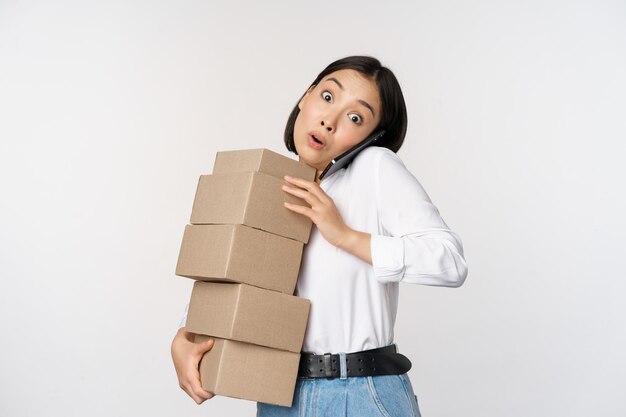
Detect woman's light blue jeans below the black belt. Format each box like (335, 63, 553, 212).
(257, 374, 420, 417)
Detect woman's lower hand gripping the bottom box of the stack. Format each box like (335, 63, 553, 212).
(172, 327, 214, 404)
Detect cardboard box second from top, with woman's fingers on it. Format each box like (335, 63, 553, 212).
(190, 172, 312, 243)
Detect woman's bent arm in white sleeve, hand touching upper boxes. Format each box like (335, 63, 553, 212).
(283, 149, 467, 287)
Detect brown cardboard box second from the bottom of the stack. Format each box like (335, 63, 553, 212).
(185, 281, 310, 352)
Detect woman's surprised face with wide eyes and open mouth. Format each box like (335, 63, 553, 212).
(293, 69, 381, 174)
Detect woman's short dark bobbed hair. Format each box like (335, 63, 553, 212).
(284, 56, 407, 155)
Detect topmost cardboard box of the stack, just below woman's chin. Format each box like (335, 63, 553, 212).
(213, 149, 315, 181)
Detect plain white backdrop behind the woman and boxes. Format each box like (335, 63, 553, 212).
(0, 0, 626, 417)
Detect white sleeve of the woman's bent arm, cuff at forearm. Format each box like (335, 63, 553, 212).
(371, 151, 467, 287)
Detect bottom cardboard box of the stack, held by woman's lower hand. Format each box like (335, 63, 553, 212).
(195, 335, 300, 407)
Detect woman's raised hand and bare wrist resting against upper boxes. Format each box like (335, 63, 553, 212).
(283, 176, 372, 264)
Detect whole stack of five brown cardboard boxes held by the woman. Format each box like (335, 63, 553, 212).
(176, 149, 315, 406)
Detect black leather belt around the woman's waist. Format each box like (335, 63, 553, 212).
(298, 345, 411, 378)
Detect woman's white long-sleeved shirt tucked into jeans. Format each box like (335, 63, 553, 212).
(296, 147, 467, 354)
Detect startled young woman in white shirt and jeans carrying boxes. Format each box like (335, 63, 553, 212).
(172, 56, 467, 417)
